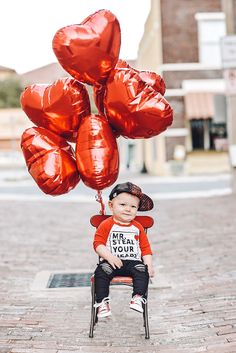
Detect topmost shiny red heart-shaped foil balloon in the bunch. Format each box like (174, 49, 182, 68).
(52, 10, 121, 85)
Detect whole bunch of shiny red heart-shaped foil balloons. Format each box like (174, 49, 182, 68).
(21, 10, 173, 195)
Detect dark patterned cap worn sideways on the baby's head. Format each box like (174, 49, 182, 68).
(109, 182, 153, 211)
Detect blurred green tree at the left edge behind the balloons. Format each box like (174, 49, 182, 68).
(0, 78, 23, 108)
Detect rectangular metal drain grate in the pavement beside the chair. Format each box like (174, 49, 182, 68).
(47, 272, 93, 288)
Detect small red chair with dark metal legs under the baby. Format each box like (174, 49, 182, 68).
(89, 215, 154, 339)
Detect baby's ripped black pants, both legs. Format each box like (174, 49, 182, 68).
(95, 260, 149, 303)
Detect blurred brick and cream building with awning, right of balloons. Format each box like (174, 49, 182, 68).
(137, 0, 229, 174)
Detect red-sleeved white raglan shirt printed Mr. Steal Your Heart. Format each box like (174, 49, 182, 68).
(93, 217, 152, 260)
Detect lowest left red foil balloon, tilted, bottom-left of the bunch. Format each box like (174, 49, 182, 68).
(21, 127, 80, 196)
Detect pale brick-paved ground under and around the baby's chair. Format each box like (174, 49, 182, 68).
(0, 196, 236, 353)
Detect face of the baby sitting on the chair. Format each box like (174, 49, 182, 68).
(109, 192, 140, 224)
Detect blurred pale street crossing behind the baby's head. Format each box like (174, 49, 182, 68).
(0, 170, 231, 202)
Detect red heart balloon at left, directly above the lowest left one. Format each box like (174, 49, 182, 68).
(20, 78, 90, 142)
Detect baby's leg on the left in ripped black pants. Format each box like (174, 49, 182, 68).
(94, 260, 116, 303)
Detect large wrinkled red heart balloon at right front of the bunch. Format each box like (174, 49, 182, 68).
(104, 68, 173, 139)
